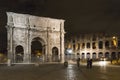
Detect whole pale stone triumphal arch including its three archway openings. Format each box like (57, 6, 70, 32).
(6, 12, 65, 63)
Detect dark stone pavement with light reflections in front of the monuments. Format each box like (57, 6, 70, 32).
(0, 63, 120, 80)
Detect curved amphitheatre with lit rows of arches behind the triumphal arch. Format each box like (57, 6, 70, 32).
(65, 33, 120, 60)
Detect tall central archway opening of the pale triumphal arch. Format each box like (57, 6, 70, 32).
(31, 37, 45, 62)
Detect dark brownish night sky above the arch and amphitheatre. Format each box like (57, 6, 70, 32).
(0, 0, 120, 51)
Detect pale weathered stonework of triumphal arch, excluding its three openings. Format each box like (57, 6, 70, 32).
(7, 12, 65, 63)
